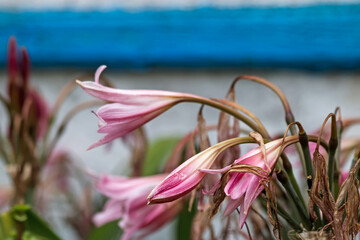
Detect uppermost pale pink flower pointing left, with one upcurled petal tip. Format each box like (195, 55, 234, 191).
(77, 65, 197, 149)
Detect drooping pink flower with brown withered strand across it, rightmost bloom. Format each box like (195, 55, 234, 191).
(202, 139, 283, 228)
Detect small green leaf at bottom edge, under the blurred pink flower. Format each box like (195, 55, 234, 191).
(88, 220, 122, 240)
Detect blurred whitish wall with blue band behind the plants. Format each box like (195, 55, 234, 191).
(0, 0, 360, 239)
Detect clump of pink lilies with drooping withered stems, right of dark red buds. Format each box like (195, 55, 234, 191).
(77, 66, 360, 239)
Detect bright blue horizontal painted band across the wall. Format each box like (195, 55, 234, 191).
(0, 4, 360, 69)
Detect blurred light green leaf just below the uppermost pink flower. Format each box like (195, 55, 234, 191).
(142, 137, 180, 176)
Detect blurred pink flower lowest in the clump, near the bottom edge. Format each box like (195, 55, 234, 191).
(93, 172, 182, 240)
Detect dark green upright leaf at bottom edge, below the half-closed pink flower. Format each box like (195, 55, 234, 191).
(176, 201, 197, 240)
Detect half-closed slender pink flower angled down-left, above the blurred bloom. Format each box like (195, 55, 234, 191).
(148, 138, 249, 203)
